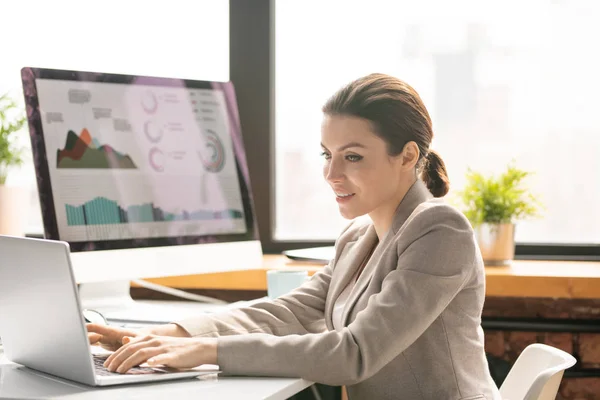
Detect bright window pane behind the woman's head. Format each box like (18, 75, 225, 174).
(274, 0, 600, 245)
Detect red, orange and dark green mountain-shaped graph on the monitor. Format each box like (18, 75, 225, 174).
(56, 128, 137, 169)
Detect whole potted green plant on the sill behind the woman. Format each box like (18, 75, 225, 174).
(459, 163, 541, 265)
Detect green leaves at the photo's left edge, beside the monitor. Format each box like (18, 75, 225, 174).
(0, 93, 26, 185)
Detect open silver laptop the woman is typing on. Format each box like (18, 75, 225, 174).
(0, 235, 218, 386)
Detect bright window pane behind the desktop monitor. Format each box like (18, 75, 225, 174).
(0, 0, 229, 232)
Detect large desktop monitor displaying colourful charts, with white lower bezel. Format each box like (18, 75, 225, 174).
(21, 68, 262, 287)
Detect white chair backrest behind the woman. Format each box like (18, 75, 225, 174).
(500, 343, 577, 400)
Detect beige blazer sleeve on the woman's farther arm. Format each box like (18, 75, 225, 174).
(176, 262, 333, 337)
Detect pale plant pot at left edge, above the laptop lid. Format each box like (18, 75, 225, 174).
(0, 185, 29, 236)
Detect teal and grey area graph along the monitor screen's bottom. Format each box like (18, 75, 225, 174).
(65, 197, 243, 226)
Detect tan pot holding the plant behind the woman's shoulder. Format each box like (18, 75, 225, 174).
(475, 223, 515, 265)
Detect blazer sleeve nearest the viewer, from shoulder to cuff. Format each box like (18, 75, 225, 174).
(217, 206, 478, 385)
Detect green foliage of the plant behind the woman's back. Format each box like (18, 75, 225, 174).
(459, 163, 542, 226)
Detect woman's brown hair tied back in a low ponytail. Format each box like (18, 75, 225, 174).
(323, 74, 450, 197)
